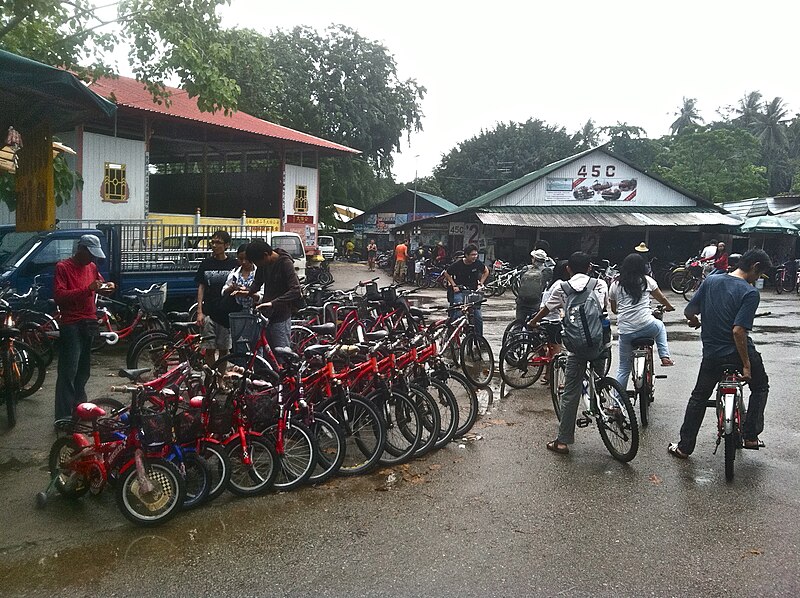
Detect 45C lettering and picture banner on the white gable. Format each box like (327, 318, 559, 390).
(545, 162, 637, 203)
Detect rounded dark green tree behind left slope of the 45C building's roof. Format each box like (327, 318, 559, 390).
(434, 119, 577, 205)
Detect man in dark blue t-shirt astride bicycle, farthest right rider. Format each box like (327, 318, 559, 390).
(667, 249, 772, 459)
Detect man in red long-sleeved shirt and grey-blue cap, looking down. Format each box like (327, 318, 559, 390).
(53, 235, 115, 420)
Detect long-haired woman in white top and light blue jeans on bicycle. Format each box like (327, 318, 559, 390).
(608, 253, 675, 388)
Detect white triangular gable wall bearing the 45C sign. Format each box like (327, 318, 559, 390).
(492, 151, 696, 207)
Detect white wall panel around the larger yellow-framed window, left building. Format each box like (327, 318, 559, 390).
(81, 133, 146, 220)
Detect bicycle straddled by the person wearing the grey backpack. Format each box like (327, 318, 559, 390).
(550, 353, 639, 463)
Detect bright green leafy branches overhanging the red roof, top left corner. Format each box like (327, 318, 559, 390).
(0, 0, 239, 112)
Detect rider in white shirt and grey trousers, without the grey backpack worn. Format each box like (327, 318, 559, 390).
(528, 251, 608, 455)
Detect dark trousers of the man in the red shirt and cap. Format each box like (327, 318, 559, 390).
(56, 321, 97, 419)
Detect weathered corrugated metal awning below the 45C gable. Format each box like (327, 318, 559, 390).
(476, 211, 740, 228)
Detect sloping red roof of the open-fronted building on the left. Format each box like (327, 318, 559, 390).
(90, 77, 360, 154)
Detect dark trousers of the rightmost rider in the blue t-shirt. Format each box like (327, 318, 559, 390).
(678, 346, 769, 455)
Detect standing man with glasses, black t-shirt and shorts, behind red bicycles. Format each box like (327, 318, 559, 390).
(194, 230, 239, 365)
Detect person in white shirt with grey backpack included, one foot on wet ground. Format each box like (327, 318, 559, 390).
(528, 251, 608, 455)
